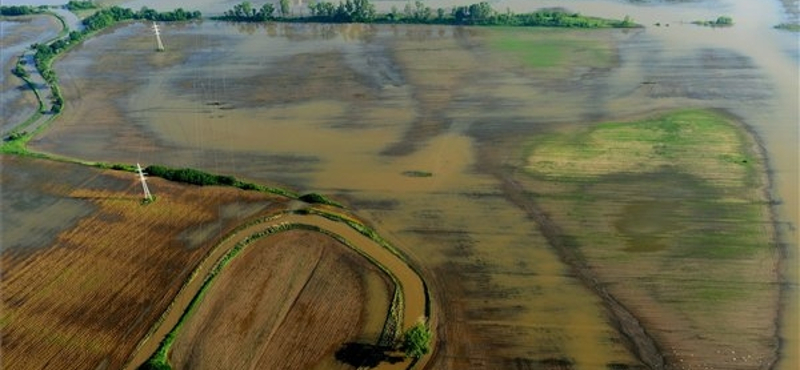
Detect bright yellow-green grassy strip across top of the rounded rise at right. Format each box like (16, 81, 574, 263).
(528, 110, 755, 185)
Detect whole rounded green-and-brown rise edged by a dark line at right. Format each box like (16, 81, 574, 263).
(519, 110, 778, 368)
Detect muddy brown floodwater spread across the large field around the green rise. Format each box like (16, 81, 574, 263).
(21, 2, 798, 369)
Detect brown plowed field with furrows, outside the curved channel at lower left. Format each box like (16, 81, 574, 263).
(0, 159, 283, 369)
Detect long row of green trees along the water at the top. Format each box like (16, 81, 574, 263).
(217, 0, 638, 28)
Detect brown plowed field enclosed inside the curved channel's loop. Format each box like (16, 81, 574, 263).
(171, 231, 389, 369)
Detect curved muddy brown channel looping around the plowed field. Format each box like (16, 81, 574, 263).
(125, 211, 435, 370)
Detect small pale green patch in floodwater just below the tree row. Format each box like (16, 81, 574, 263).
(489, 28, 615, 68)
